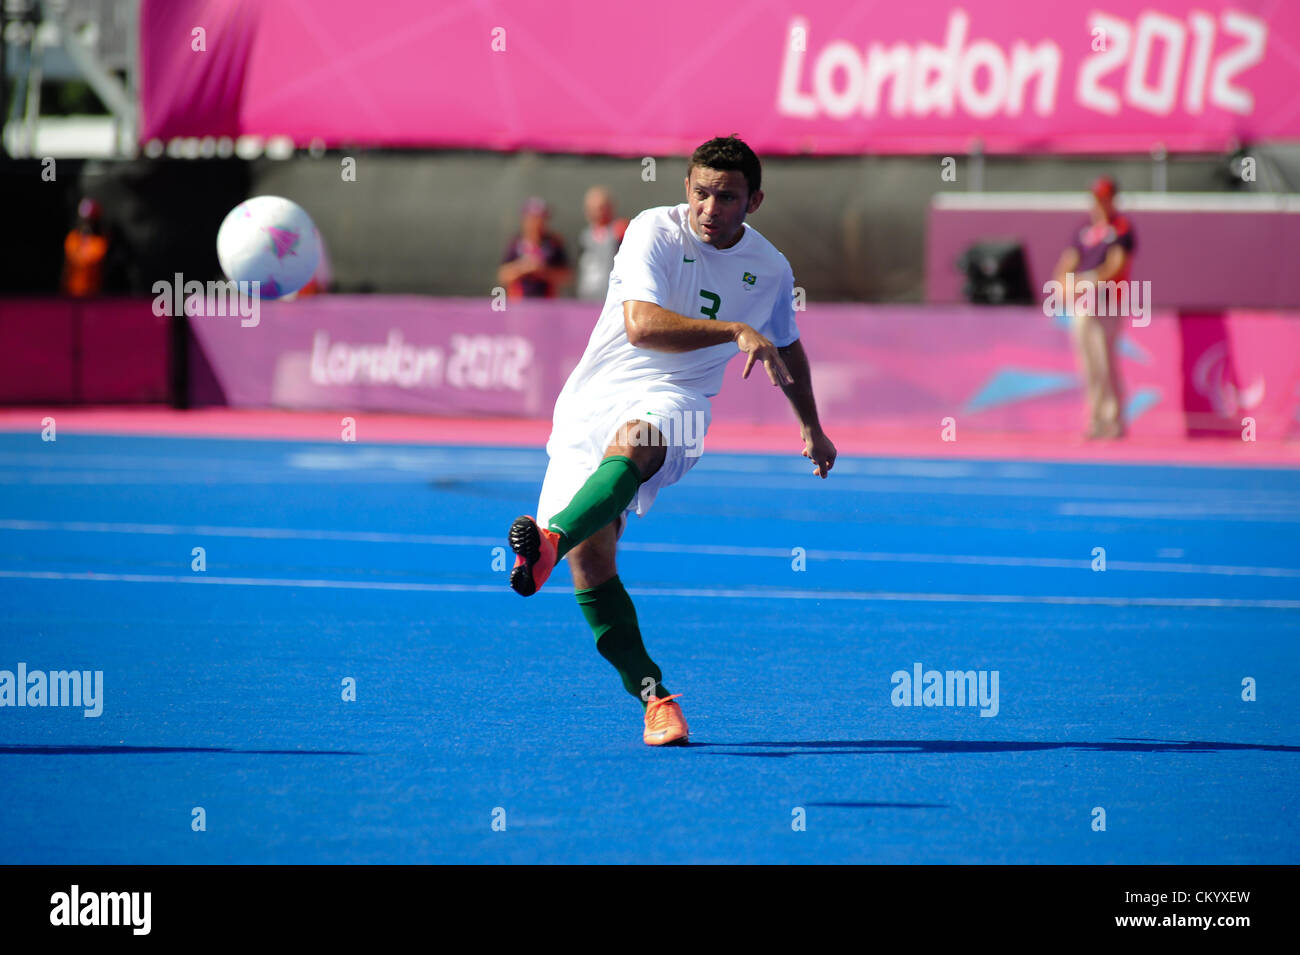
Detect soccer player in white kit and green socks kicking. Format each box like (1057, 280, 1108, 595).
(510, 136, 836, 746)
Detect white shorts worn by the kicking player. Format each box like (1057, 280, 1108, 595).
(537, 385, 712, 537)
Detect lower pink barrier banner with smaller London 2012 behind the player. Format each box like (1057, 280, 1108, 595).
(189, 296, 1300, 440)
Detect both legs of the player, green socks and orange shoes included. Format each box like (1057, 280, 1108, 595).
(510, 421, 689, 746)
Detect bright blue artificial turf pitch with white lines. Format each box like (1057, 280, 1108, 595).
(0, 433, 1300, 863)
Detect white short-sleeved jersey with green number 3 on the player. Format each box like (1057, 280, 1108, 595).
(560, 203, 800, 407)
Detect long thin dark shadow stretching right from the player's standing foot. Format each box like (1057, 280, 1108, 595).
(690, 737, 1300, 756)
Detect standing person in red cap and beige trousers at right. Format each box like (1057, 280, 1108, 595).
(1054, 175, 1135, 439)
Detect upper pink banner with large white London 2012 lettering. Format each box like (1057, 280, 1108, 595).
(140, 0, 1300, 156)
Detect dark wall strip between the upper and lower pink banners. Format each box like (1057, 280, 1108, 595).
(0, 147, 1300, 301)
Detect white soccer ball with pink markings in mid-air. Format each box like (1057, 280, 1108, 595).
(217, 196, 321, 299)
